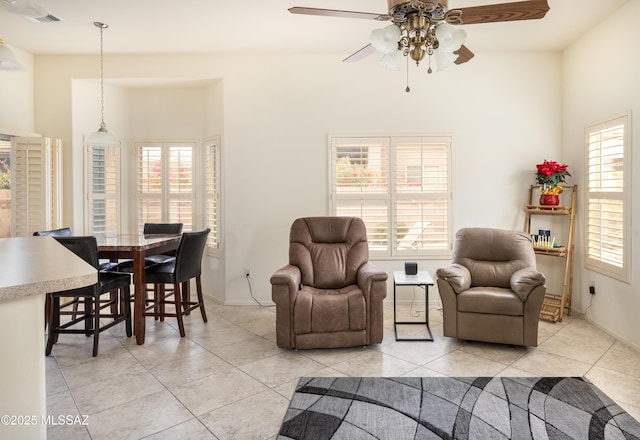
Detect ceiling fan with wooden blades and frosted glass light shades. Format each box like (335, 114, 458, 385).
(289, 0, 549, 73)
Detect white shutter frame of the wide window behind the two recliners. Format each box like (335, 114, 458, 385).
(328, 133, 453, 260)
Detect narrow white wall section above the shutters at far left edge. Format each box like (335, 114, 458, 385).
(0, 45, 34, 136)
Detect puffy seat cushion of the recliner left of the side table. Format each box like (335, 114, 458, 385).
(293, 285, 367, 334)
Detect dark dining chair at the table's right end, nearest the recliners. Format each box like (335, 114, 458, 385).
(145, 228, 211, 337)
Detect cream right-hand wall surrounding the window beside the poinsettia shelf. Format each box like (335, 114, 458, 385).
(562, 1, 640, 348)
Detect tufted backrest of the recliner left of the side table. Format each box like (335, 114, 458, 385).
(289, 217, 369, 289)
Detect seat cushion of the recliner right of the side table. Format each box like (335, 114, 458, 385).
(458, 287, 524, 316)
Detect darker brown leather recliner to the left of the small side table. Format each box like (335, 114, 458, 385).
(271, 217, 387, 348)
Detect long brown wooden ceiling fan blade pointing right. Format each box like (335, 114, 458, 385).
(456, 0, 549, 24)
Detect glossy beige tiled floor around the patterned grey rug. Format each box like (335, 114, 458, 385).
(46, 301, 640, 440)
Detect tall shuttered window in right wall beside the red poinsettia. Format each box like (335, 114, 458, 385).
(585, 114, 631, 282)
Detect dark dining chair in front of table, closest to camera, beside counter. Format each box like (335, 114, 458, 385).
(45, 236, 132, 356)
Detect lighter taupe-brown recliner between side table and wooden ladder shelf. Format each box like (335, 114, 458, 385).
(436, 228, 546, 347)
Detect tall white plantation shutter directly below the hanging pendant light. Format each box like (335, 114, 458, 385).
(85, 146, 122, 234)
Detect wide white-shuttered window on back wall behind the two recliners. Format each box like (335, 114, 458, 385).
(329, 136, 452, 258)
